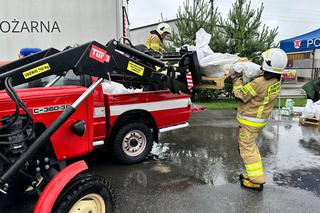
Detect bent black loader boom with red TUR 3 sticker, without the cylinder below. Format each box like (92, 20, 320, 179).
(0, 40, 188, 93)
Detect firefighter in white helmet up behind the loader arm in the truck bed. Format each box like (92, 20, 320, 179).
(146, 23, 172, 53)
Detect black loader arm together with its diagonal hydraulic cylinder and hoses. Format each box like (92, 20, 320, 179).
(0, 40, 188, 191)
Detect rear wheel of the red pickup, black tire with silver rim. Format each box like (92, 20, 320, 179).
(112, 122, 153, 164)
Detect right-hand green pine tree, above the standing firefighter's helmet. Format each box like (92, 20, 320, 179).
(219, 0, 278, 57)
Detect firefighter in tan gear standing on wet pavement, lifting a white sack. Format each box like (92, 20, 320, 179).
(233, 48, 288, 191)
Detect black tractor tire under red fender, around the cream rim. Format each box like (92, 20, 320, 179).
(52, 174, 116, 213)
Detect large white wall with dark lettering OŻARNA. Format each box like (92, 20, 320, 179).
(0, 0, 122, 60)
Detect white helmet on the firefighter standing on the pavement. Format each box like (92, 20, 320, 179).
(262, 48, 288, 74)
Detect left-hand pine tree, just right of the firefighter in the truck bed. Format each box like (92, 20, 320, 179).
(171, 0, 220, 47)
